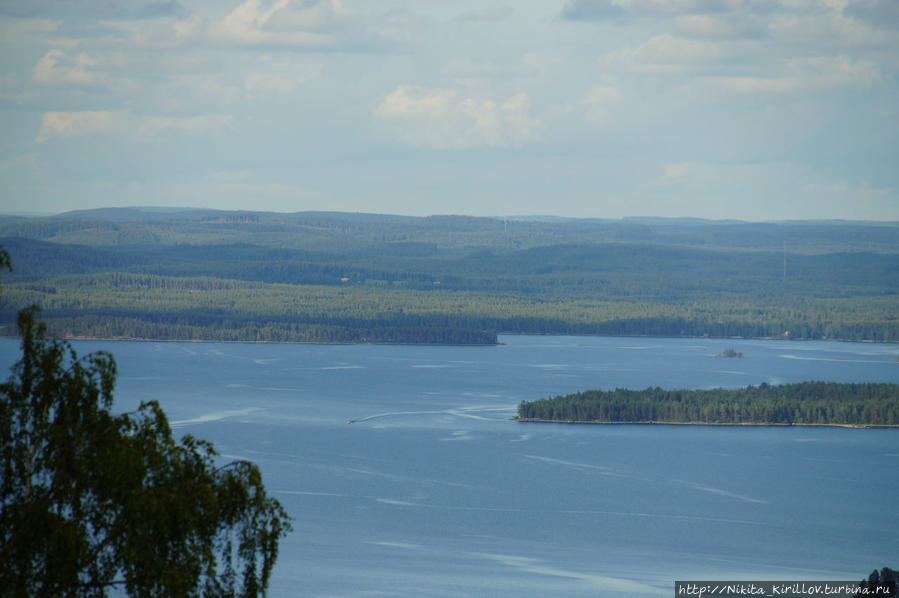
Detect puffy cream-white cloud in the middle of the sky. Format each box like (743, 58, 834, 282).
(376, 85, 539, 149)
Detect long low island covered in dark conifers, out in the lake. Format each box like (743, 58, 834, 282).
(517, 382, 899, 426)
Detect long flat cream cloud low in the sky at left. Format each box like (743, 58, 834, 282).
(34, 110, 232, 143)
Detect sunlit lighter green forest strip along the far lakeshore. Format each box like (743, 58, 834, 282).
(7, 272, 899, 344)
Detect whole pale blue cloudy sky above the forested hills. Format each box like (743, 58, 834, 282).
(0, 0, 899, 221)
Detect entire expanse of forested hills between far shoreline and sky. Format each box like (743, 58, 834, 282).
(0, 208, 899, 344)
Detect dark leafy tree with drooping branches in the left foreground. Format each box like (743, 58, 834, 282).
(0, 252, 290, 597)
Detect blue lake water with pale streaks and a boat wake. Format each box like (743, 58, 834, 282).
(0, 336, 899, 598)
